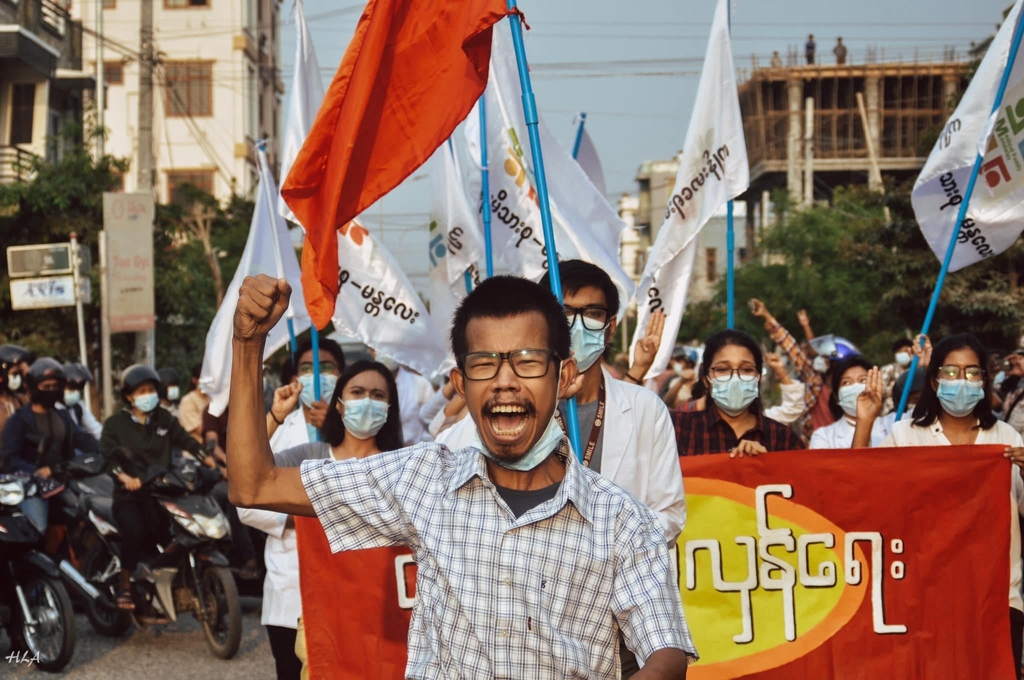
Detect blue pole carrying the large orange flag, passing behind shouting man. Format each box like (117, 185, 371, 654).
(507, 0, 583, 462)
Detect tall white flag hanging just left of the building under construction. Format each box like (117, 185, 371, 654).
(633, 0, 751, 378)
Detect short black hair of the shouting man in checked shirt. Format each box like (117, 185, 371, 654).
(452, 277, 571, 358)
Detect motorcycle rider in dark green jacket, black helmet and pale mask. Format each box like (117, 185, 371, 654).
(99, 364, 214, 610)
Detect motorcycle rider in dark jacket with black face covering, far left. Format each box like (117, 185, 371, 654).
(0, 356, 98, 533)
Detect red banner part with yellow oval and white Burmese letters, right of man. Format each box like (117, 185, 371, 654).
(678, 447, 1017, 680)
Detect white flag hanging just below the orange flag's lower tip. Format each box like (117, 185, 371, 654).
(332, 220, 447, 383)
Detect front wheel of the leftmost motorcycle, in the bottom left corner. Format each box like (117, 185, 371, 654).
(13, 576, 75, 673)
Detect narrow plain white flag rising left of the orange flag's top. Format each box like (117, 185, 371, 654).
(278, 0, 324, 222)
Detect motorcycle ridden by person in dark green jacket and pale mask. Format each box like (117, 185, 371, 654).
(82, 461, 242, 658)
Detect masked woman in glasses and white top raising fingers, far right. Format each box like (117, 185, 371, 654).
(854, 333, 1024, 678)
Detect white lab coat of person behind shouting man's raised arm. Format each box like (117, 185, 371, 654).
(239, 409, 309, 628)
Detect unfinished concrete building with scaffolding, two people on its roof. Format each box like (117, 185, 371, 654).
(739, 61, 969, 209)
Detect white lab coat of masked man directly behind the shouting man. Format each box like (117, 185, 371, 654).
(437, 369, 686, 544)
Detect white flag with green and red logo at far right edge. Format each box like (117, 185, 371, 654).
(910, 0, 1024, 271)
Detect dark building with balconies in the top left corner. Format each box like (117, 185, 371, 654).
(0, 0, 93, 182)
